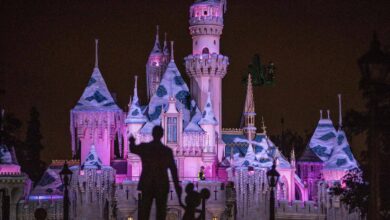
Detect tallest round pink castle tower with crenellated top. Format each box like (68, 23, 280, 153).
(185, 0, 229, 134)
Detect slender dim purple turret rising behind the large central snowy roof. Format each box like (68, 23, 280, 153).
(146, 26, 169, 99)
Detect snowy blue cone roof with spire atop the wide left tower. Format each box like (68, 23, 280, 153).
(73, 40, 120, 111)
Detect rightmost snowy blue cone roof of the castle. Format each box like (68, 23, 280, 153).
(324, 129, 358, 170)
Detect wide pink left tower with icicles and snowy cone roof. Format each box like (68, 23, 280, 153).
(70, 40, 123, 165)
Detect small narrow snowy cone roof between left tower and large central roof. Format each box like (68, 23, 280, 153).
(125, 76, 147, 124)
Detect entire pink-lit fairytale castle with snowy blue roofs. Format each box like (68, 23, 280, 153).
(0, 0, 366, 220)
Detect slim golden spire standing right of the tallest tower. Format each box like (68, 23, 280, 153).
(243, 74, 256, 140)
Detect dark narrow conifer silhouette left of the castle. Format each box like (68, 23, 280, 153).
(22, 107, 46, 183)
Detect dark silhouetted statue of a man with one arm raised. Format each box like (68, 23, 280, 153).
(129, 126, 182, 220)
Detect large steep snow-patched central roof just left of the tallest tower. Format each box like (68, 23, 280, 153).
(145, 42, 202, 133)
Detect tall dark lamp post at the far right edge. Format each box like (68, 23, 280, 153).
(358, 33, 390, 219)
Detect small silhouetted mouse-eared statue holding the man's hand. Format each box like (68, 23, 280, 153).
(182, 183, 202, 220)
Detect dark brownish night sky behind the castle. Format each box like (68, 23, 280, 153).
(0, 0, 390, 160)
